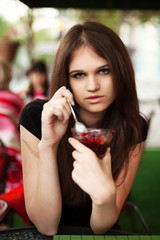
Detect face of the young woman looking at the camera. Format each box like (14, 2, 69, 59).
(69, 46, 115, 120)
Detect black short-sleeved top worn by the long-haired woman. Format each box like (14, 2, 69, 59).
(19, 99, 148, 227)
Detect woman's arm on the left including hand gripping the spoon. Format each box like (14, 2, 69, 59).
(20, 89, 73, 235)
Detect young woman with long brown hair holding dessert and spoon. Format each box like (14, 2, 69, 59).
(20, 22, 147, 235)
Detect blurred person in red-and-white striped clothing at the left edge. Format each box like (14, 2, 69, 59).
(0, 56, 24, 192)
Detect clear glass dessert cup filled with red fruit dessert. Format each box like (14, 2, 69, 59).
(71, 128, 114, 158)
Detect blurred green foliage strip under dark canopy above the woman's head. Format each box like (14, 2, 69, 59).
(66, 9, 160, 34)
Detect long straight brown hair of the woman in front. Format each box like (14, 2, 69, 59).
(50, 22, 142, 205)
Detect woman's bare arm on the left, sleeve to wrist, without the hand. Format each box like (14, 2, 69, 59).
(20, 126, 61, 235)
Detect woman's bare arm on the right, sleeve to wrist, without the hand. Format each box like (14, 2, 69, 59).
(91, 143, 144, 233)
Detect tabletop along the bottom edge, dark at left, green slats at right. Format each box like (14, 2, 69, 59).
(0, 227, 160, 240)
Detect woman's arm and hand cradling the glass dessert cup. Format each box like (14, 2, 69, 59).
(69, 138, 144, 234)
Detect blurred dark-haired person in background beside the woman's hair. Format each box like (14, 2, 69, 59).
(19, 61, 49, 103)
